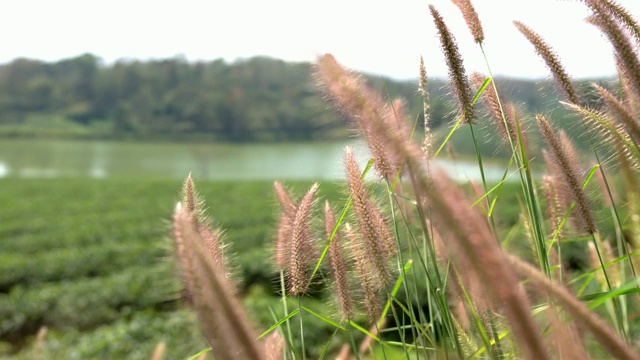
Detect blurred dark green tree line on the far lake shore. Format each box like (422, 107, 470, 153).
(0, 54, 604, 142)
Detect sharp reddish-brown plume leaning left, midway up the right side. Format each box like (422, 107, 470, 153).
(536, 115, 597, 234)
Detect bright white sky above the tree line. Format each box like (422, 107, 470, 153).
(5, 0, 640, 79)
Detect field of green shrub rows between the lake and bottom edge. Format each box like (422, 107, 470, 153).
(0, 178, 352, 359)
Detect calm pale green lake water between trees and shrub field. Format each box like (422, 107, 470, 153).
(0, 139, 504, 180)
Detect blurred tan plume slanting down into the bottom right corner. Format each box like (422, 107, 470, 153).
(505, 254, 640, 360)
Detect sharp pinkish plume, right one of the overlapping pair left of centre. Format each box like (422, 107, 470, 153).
(288, 183, 318, 296)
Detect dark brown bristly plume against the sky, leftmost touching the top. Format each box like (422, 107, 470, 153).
(429, 5, 475, 124)
